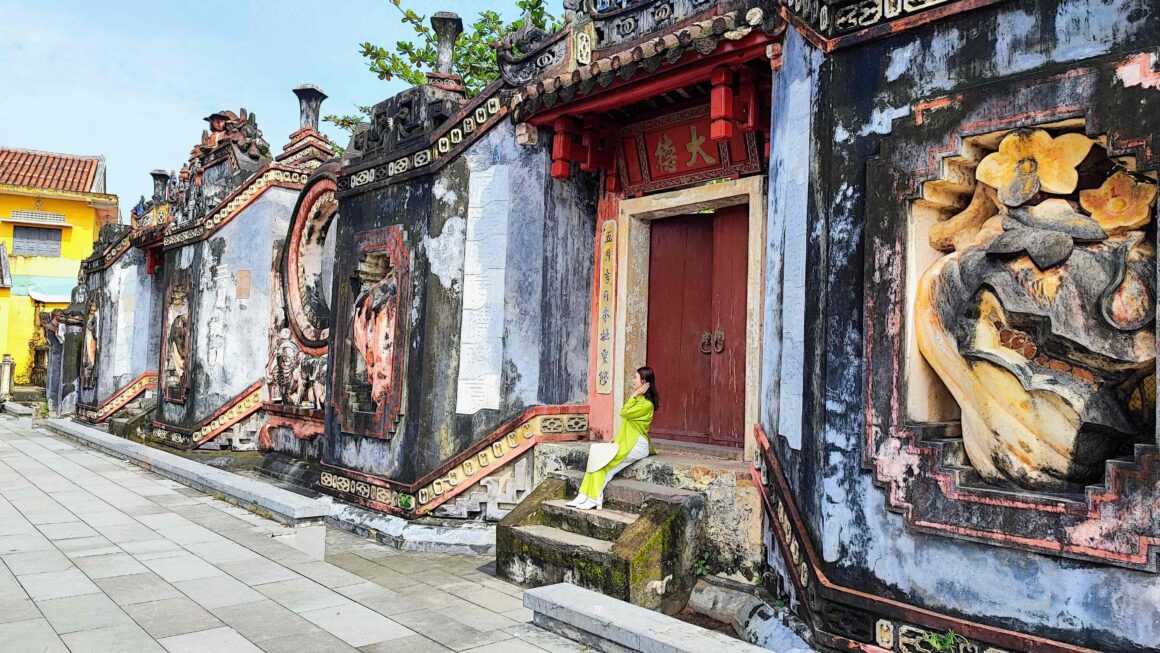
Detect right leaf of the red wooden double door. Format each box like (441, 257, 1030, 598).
(709, 205, 749, 445)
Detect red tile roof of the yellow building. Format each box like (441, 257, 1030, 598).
(0, 147, 104, 193)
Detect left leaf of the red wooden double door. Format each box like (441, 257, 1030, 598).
(646, 216, 712, 441)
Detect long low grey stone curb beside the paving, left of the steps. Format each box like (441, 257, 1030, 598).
(36, 420, 331, 527)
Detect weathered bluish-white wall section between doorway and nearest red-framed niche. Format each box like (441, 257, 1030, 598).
(324, 121, 595, 483)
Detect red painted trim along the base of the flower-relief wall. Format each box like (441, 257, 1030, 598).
(749, 423, 1097, 653)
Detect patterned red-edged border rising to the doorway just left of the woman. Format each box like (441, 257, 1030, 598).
(318, 405, 588, 517)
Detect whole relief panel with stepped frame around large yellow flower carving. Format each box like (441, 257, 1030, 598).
(864, 60, 1160, 572)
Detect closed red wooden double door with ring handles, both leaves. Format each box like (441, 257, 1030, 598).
(647, 206, 748, 445)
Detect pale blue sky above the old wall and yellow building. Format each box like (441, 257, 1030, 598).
(0, 0, 524, 212)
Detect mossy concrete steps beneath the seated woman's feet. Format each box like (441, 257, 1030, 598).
(495, 470, 705, 615)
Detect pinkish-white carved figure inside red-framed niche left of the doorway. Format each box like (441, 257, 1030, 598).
(353, 256, 399, 404)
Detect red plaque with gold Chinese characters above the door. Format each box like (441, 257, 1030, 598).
(617, 104, 761, 195)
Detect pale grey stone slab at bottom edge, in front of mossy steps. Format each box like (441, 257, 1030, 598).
(523, 582, 768, 653)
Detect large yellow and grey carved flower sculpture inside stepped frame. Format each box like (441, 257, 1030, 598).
(914, 130, 1157, 491)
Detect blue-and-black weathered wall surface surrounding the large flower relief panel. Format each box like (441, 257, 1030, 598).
(763, 0, 1160, 651)
